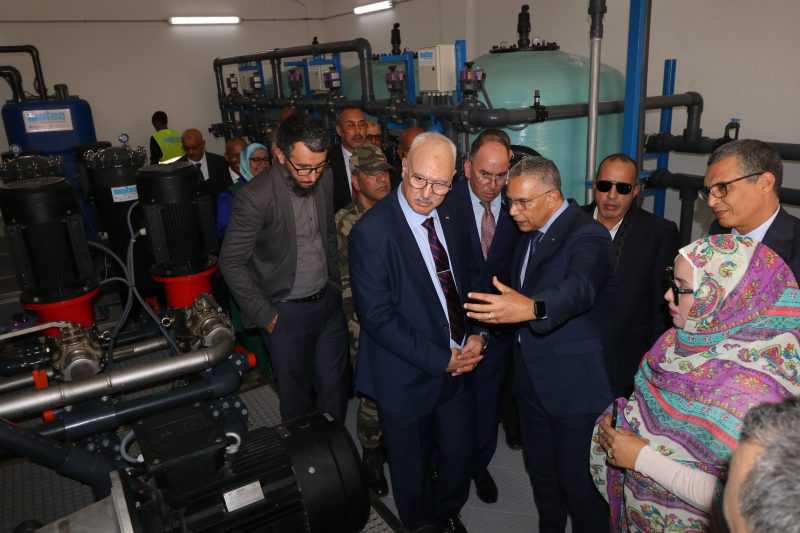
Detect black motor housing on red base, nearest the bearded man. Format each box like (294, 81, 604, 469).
(136, 161, 218, 276)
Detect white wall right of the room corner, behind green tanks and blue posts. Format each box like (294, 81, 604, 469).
(325, 0, 800, 235)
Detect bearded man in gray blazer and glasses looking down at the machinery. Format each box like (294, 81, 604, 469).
(219, 115, 350, 421)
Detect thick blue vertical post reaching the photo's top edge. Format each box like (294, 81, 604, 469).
(622, 0, 652, 168)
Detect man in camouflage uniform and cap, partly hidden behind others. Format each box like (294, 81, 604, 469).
(336, 144, 392, 496)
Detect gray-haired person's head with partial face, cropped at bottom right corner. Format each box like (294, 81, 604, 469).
(722, 397, 800, 533)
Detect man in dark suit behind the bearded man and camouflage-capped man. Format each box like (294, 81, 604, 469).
(328, 107, 367, 211)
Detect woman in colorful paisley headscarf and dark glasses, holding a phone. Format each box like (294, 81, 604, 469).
(589, 235, 800, 532)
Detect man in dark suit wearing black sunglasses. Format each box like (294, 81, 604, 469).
(583, 154, 679, 398)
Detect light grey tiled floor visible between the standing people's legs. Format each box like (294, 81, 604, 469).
(346, 400, 572, 533)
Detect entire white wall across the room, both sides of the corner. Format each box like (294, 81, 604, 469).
(0, 0, 800, 233)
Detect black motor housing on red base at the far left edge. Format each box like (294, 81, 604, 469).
(0, 177, 97, 303)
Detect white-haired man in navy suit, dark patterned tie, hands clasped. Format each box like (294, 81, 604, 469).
(349, 133, 485, 532)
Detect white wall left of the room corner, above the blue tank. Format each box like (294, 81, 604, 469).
(0, 0, 324, 152)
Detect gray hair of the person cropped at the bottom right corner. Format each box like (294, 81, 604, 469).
(739, 397, 800, 533)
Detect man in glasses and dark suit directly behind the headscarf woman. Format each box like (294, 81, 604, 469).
(700, 139, 800, 279)
